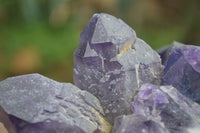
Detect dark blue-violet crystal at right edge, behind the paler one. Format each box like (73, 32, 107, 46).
(163, 42, 200, 103)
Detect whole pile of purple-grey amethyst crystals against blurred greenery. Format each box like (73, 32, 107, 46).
(0, 13, 200, 133)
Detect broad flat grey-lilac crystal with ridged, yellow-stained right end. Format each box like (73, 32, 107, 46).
(0, 74, 110, 133)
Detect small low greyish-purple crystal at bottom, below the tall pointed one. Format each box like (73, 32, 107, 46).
(112, 114, 169, 133)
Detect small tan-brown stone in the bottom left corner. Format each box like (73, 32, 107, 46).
(0, 106, 16, 133)
